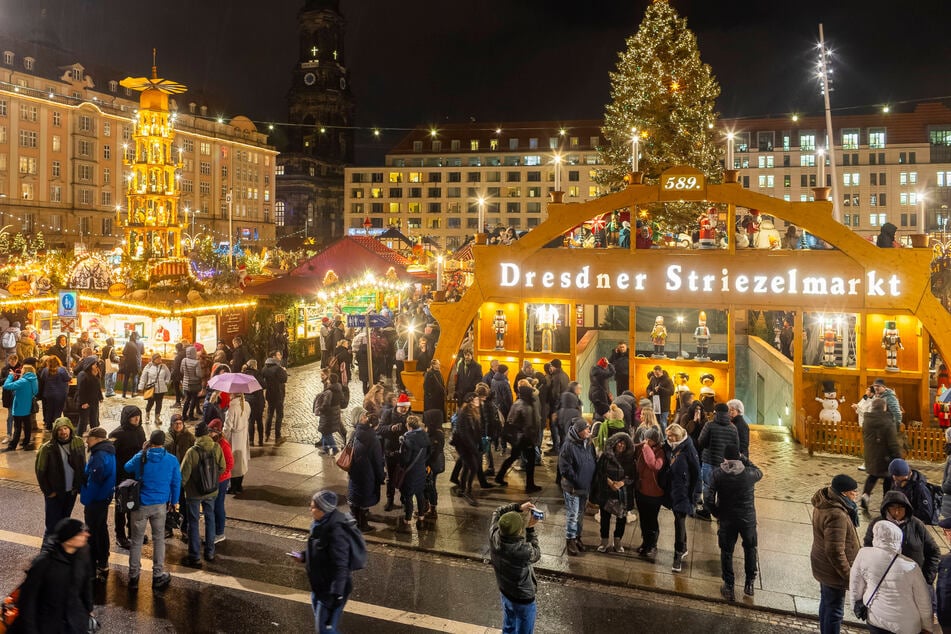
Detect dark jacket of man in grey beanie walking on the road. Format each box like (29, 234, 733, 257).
(304, 509, 356, 603)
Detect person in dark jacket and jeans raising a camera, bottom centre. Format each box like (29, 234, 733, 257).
(489, 502, 541, 632)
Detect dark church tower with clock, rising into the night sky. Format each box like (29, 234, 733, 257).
(276, 0, 354, 245)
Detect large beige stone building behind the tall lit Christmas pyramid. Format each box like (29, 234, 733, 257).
(0, 38, 277, 249)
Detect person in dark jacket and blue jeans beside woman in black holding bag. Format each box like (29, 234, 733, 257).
(558, 416, 597, 557)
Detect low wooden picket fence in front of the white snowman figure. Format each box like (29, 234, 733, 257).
(803, 417, 946, 462)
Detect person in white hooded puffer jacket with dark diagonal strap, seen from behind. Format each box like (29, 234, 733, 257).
(849, 522, 933, 634)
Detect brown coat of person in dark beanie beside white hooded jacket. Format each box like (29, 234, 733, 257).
(809, 487, 861, 590)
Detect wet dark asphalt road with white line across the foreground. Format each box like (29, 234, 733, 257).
(0, 485, 832, 634)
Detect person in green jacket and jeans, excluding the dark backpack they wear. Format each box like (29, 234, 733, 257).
(182, 422, 225, 568)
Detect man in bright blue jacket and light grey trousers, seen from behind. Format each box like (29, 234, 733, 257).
(125, 429, 182, 590)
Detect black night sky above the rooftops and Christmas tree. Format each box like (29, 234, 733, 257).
(0, 0, 951, 161)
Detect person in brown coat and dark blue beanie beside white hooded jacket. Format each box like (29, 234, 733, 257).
(809, 474, 861, 634)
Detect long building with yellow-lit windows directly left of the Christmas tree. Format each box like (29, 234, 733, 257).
(344, 121, 602, 249)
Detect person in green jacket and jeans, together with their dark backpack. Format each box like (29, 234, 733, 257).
(181, 422, 227, 568)
